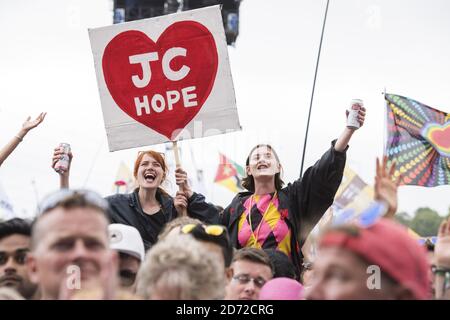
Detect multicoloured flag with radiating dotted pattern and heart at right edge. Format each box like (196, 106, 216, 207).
(385, 94, 450, 187)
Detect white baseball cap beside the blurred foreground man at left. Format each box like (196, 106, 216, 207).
(108, 223, 145, 262)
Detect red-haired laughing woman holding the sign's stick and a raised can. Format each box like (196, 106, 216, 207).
(53, 148, 218, 250)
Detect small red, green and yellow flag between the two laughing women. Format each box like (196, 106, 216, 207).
(214, 153, 245, 193)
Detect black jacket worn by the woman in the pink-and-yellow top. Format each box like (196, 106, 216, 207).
(221, 140, 348, 274)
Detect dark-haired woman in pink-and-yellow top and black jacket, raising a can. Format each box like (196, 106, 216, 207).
(222, 107, 365, 274)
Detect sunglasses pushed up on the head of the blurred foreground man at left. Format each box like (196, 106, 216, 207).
(38, 189, 108, 215)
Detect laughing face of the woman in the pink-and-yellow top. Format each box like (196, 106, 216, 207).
(246, 145, 281, 179)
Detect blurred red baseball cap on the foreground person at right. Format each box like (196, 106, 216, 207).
(319, 218, 430, 299)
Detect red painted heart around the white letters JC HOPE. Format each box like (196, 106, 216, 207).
(102, 21, 218, 140)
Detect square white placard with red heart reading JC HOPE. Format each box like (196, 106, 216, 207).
(89, 6, 240, 151)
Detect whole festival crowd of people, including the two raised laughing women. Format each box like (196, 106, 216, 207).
(0, 108, 450, 300)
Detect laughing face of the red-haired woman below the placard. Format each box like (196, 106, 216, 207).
(135, 153, 166, 189)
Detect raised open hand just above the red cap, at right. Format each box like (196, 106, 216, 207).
(375, 156, 399, 218)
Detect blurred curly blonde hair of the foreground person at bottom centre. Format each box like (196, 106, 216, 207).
(137, 235, 226, 300)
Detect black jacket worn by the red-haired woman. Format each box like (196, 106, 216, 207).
(105, 189, 219, 250)
